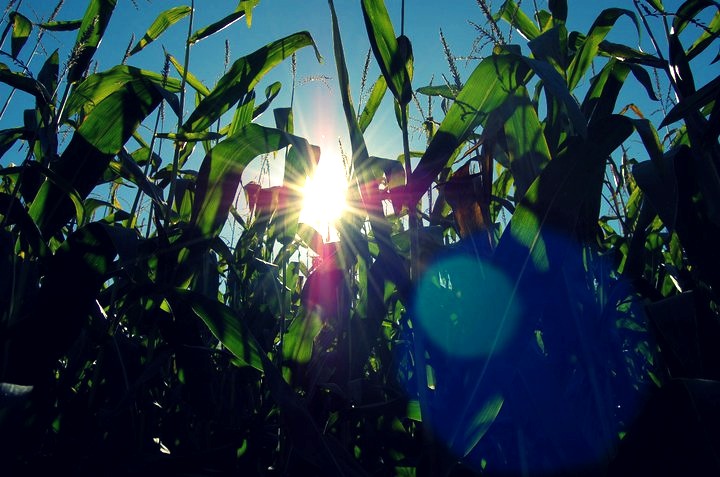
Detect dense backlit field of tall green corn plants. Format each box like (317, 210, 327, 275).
(0, 0, 720, 477)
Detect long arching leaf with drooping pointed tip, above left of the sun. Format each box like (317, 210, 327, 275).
(182, 32, 321, 132)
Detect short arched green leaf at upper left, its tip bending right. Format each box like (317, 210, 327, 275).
(65, 65, 180, 121)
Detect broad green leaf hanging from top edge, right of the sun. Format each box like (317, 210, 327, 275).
(362, 0, 412, 106)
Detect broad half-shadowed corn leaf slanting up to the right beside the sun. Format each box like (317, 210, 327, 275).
(404, 55, 530, 204)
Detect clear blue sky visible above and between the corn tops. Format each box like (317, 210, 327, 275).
(0, 0, 717, 178)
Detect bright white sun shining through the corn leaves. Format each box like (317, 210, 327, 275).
(300, 156, 348, 242)
